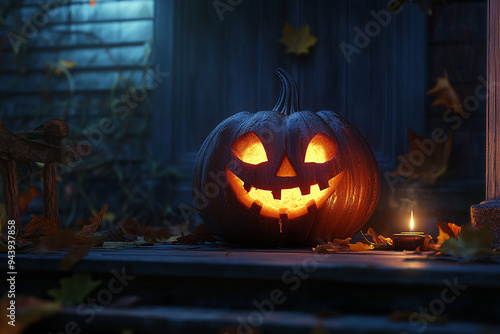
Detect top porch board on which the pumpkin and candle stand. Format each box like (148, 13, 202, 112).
(0, 244, 500, 288)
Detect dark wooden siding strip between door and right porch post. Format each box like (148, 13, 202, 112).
(428, 1, 487, 180)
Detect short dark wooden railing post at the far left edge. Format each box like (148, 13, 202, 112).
(0, 159, 21, 229)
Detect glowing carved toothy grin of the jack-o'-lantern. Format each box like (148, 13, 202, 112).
(226, 169, 344, 219)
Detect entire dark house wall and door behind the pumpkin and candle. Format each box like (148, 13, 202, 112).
(0, 0, 486, 240)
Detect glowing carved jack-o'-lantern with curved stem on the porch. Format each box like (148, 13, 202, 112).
(193, 69, 380, 246)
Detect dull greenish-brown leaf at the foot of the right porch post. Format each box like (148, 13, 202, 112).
(439, 225, 494, 261)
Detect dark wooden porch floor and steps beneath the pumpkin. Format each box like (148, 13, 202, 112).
(0, 244, 500, 333)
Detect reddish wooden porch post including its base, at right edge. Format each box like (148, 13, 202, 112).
(471, 0, 500, 248)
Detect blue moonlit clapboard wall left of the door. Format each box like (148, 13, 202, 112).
(0, 0, 154, 222)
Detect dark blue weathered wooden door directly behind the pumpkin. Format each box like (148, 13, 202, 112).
(154, 0, 426, 202)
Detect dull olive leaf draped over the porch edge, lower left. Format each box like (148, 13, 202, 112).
(47, 273, 101, 305)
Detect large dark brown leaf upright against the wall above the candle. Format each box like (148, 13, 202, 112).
(389, 129, 453, 185)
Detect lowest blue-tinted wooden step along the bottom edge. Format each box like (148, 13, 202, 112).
(35, 306, 492, 334)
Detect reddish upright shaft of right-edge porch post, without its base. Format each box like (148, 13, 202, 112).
(486, 0, 500, 200)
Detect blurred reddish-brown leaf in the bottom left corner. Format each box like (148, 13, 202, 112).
(0, 294, 62, 334)
